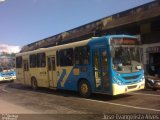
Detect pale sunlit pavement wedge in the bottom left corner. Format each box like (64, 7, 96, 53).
(0, 100, 36, 114)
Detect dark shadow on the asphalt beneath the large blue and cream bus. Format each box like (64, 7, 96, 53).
(6, 83, 132, 101)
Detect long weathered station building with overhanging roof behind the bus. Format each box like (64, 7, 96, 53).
(21, 0, 160, 75)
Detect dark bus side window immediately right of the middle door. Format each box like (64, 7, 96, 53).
(59, 48, 73, 66)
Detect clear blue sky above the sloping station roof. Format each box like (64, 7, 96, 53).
(0, 0, 153, 47)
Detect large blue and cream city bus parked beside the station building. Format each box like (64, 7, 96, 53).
(16, 35, 145, 97)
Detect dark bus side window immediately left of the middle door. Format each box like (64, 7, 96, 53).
(37, 53, 46, 67)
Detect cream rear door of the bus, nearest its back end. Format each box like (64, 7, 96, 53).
(23, 60, 31, 85)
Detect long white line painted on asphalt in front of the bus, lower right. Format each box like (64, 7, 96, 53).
(84, 99, 160, 112)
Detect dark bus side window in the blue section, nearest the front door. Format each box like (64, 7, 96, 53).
(75, 46, 89, 65)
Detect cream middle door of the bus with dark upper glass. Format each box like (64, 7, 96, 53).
(48, 56, 57, 88)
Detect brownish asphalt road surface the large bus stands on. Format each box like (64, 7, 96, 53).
(0, 83, 160, 120)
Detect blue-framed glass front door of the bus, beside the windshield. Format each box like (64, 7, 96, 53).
(93, 48, 109, 92)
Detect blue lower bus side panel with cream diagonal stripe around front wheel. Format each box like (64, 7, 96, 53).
(57, 66, 94, 91)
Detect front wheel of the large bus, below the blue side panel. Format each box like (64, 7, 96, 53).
(78, 80, 91, 98)
